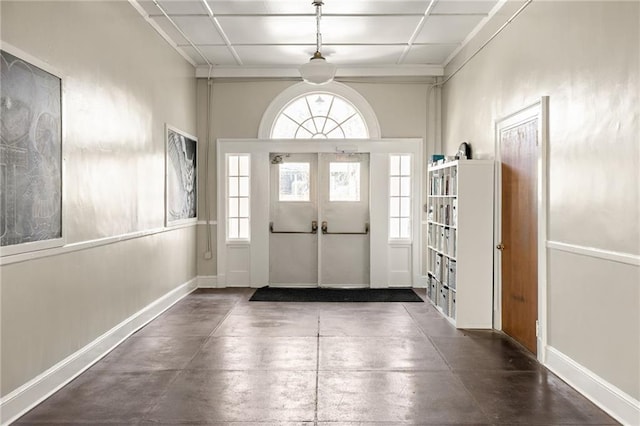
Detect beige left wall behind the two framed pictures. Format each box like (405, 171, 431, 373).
(1, 1, 196, 395)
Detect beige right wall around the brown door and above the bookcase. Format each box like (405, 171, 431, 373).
(443, 1, 640, 399)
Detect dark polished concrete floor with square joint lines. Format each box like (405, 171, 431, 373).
(18, 289, 616, 426)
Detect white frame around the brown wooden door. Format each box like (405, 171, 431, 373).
(493, 96, 549, 363)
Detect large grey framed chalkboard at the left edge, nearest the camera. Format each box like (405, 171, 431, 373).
(0, 50, 62, 247)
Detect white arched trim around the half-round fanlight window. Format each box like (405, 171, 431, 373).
(258, 81, 380, 141)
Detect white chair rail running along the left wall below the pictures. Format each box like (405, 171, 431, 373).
(0, 223, 196, 266)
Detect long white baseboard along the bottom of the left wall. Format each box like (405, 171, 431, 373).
(0, 278, 196, 425)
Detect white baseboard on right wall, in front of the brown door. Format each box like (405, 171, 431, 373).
(545, 346, 640, 426)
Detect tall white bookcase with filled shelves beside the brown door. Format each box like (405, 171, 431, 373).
(426, 160, 494, 328)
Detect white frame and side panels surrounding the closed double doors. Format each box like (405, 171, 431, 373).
(215, 138, 425, 288)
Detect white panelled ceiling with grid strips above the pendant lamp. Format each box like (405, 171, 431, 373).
(129, 0, 504, 77)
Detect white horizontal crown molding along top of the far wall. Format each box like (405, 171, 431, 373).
(195, 64, 444, 80)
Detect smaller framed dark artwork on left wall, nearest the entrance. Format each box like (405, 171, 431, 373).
(165, 125, 198, 226)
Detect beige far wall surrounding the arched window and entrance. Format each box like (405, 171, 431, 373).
(198, 80, 435, 275)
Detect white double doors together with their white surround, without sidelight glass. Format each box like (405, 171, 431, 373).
(216, 139, 423, 288)
